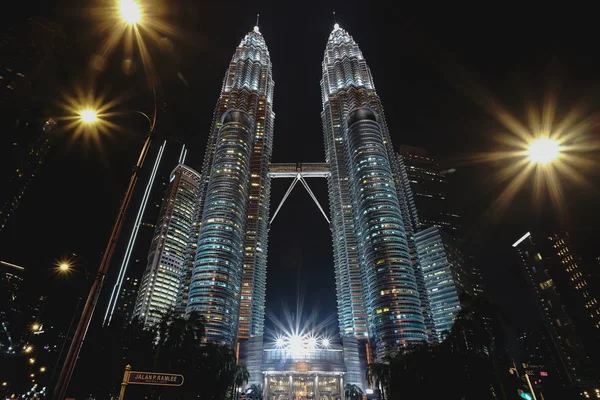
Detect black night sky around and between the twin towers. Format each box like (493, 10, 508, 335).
(0, 0, 600, 338)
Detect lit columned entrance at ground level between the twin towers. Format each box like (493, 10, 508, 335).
(263, 371, 344, 400)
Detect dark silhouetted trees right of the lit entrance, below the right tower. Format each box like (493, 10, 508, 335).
(378, 296, 509, 400)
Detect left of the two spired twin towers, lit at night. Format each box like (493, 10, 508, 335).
(186, 26, 275, 344)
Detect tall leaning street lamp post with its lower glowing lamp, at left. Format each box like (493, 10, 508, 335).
(53, 88, 157, 400)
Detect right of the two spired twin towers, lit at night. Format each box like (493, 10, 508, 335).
(321, 24, 427, 360)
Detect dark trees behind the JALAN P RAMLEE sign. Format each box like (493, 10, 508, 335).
(71, 313, 239, 400)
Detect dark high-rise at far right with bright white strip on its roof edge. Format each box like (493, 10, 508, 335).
(512, 232, 600, 385)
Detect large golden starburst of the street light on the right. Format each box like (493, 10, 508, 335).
(460, 92, 600, 222)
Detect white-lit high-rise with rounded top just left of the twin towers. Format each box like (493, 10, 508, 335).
(133, 164, 200, 326)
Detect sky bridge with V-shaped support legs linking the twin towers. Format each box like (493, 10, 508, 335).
(268, 163, 331, 224)
